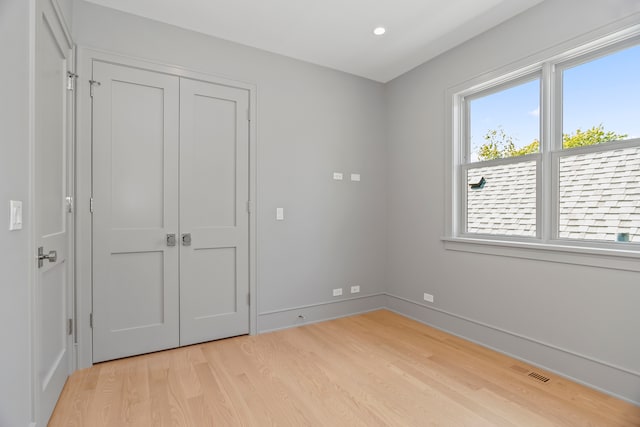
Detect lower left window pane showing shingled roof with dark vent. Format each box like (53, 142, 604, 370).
(466, 160, 537, 237)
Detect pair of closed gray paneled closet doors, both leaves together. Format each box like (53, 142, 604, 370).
(92, 61, 249, 362)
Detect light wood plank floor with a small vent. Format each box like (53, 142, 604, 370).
(49, 310, 640, 427)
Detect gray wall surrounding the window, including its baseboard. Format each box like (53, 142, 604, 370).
(386, 0, 640, 403)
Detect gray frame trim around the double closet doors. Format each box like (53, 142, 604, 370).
(76, 46, 258, 369)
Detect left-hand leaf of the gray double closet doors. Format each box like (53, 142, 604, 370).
(93, 62, 179, 362)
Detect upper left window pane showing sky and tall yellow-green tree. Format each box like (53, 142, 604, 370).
(468, 79, 540, 162)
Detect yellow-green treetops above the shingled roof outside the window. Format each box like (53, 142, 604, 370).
(478, 124, 628, 160)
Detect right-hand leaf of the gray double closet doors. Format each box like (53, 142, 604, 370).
(180, 78, 249, 345)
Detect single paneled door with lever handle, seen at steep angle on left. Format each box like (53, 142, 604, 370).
(34, 1, 72, 425)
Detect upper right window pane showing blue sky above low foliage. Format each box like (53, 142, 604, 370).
(562, 45, 640, 148)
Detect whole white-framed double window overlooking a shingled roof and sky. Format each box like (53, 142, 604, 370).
(451, 31, 640, 251)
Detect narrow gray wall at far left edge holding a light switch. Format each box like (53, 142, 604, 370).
(0, 0, 31, 426)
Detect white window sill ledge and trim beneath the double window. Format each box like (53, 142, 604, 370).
(441, 237, 640, 271)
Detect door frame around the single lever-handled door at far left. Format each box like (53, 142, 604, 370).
(25, 0, 78, 426)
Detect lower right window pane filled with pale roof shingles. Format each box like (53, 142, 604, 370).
(559, 147, 640, 242)
